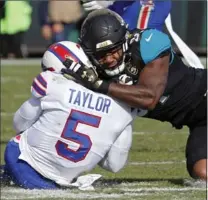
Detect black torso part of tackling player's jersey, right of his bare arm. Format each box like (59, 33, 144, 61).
(141, 55, 207, 128)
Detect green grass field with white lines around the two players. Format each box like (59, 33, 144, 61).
(1, 66, 206, 200)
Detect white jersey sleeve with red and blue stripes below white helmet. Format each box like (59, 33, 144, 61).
(31, 71, 52, 98)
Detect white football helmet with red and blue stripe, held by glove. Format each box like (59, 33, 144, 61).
(41, 41, 91, 73)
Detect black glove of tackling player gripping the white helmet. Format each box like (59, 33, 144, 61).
(61, 59, 110, 94)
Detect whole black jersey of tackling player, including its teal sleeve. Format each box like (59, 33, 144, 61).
(130, 29, 207, 128)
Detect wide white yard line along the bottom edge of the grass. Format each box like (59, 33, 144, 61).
(1, 184, 206, 199)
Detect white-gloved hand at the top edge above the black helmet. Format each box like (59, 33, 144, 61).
(82, 0, 114, 11)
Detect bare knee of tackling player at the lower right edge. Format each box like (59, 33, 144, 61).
(191, 159, 208, 180)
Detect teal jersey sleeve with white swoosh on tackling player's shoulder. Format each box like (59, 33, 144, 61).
(140, 29, 171, 64)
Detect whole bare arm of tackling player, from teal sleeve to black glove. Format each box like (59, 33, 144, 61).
(111, 54, 170, 110)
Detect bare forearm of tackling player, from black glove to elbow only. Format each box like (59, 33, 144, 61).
(108, 83, 155, 109)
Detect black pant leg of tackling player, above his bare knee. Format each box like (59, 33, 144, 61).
(186, 123, 207, 176)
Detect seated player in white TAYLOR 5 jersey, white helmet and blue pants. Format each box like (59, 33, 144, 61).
(5, 41, 136, 189)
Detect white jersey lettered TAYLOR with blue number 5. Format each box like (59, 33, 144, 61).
(19, 71, 135, 185)
